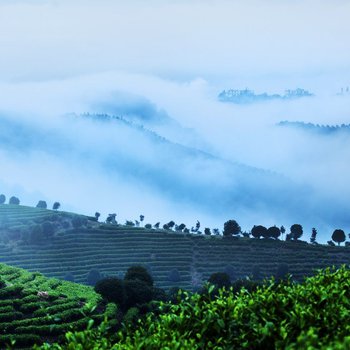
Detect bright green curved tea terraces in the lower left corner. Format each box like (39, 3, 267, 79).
(0, 264, 116, 349)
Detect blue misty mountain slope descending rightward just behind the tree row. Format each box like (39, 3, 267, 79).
(0, 106, 348, 242)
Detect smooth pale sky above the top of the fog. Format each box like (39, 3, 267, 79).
(0, 0, 350, 80)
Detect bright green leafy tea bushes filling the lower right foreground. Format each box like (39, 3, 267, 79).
(36, 266, 350, 349)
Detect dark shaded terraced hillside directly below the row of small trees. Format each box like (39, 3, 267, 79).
(0, 205, 350, 289)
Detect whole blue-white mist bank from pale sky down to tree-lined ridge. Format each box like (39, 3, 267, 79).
(0, 68, 350, 242)
